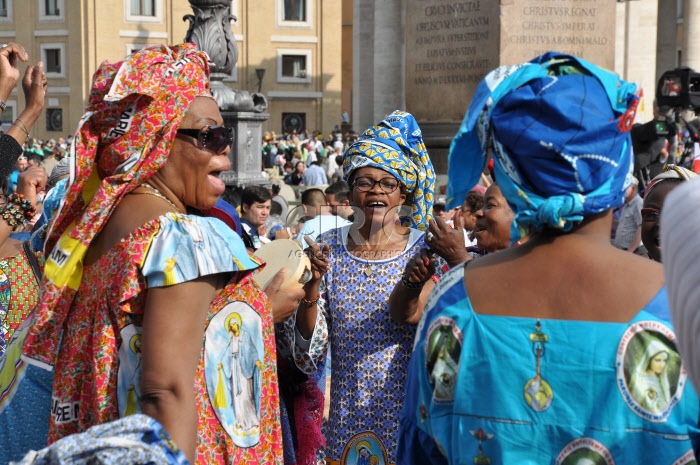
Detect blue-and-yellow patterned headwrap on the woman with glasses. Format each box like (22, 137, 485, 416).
(343, 110, 435, 230)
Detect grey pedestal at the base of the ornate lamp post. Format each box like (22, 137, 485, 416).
(219, 111, 270, 188)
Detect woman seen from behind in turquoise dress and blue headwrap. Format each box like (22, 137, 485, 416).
(397, 53, 700, 465)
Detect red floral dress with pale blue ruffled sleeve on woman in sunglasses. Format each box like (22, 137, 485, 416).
(24, 213, 282, 464)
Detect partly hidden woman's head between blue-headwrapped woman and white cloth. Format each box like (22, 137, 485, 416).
(642, 165, 695, 262)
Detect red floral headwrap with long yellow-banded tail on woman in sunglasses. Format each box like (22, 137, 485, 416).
(25, 44, 211, 364)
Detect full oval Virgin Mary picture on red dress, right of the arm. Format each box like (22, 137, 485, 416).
(204, 302, 263, 447)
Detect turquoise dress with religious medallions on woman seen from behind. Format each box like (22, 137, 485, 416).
(397, 265, 700, 465)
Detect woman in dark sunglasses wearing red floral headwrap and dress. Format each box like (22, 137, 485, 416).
(24, 44, 282, 464)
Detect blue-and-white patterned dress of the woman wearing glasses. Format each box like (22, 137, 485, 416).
(287, 226, 424, 465)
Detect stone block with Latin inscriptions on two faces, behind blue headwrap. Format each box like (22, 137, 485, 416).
(405, 0, 616, 123)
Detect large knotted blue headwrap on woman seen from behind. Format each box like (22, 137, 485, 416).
(447, 52, 639, 242)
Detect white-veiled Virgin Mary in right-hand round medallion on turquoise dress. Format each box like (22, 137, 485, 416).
(629, 338, 678, 413)
